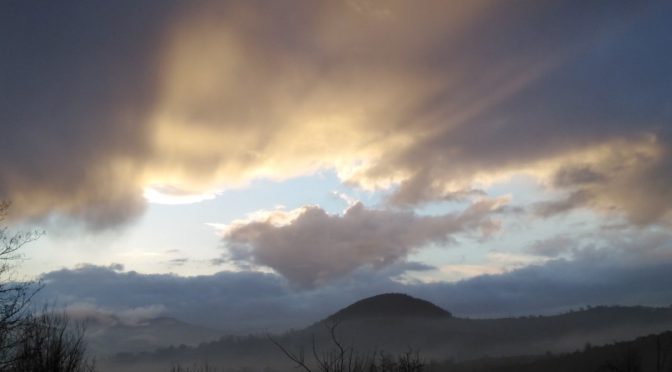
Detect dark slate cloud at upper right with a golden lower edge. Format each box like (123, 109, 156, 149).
(369, 2, 672, 224)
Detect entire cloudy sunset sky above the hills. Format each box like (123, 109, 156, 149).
(0, 0, 672, 331)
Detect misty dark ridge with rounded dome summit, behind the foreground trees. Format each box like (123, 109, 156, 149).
(101, 294, 672, 372)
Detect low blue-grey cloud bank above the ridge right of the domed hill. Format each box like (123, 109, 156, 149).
(414, 260, 672, 317)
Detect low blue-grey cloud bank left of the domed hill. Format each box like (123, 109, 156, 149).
(34, 265, 302, 333)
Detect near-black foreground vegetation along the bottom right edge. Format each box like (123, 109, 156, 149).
(159, 332, 672, 372)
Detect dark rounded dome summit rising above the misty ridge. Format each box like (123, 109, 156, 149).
(325, 293, 452, 322)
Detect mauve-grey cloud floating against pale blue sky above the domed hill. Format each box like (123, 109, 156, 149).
(221, 199, 505, 287)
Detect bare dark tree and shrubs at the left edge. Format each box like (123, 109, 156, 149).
(0, 201, 95, 372)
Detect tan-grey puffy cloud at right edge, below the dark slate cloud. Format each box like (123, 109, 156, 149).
(533, 135, 672, 226)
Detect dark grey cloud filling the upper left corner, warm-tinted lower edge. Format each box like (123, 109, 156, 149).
(0, 1, 186, 228)
